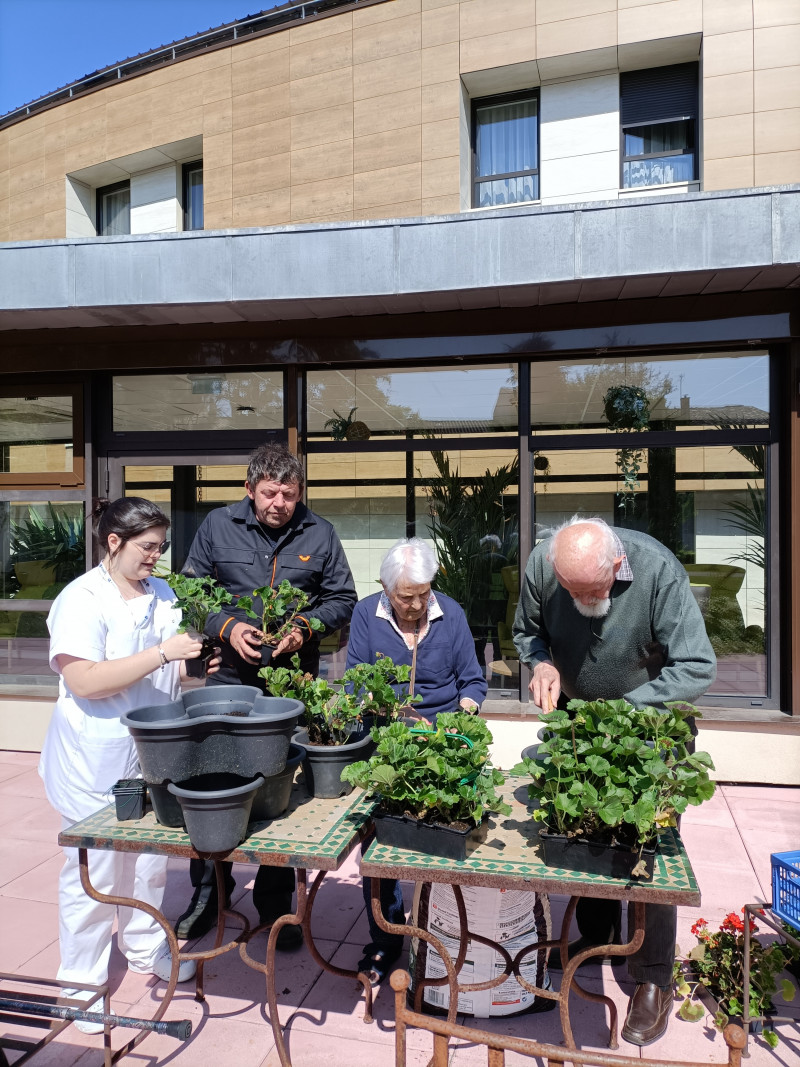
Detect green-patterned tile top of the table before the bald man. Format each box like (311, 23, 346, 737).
(362, 778, 700, 905)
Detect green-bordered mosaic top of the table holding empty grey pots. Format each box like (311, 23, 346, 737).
(59, 783, 374, 871)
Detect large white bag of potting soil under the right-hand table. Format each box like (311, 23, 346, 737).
(409, 882, 551, 1019)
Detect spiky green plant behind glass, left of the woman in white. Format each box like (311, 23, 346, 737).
(9, 504, 86, 583)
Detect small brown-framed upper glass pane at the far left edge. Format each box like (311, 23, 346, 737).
(0, 396, 73, 474)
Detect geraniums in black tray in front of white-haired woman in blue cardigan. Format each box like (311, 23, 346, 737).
(342, 712, 511, 859)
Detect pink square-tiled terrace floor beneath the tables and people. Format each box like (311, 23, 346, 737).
(0, 751, 800, 1067)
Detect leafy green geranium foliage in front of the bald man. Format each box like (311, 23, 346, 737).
(511, 700, 715, 877)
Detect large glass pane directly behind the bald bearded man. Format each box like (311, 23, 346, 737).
(533, 445, 769, 697)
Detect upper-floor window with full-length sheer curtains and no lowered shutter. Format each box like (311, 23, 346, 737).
(473, 91, 539, 207)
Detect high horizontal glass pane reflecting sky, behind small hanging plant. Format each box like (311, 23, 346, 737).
(531, 352, 769, 433)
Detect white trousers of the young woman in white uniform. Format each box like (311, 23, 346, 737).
(58, 816, 167, 987)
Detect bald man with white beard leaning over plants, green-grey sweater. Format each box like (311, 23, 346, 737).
(513, 515, 717, 1046)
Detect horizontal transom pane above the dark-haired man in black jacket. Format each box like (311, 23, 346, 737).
(113, 370, 284, 433)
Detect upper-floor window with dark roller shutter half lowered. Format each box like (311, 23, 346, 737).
(620, 63, 698, 189)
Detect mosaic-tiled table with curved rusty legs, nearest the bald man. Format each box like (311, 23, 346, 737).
(361, 778, 700, 1049)
